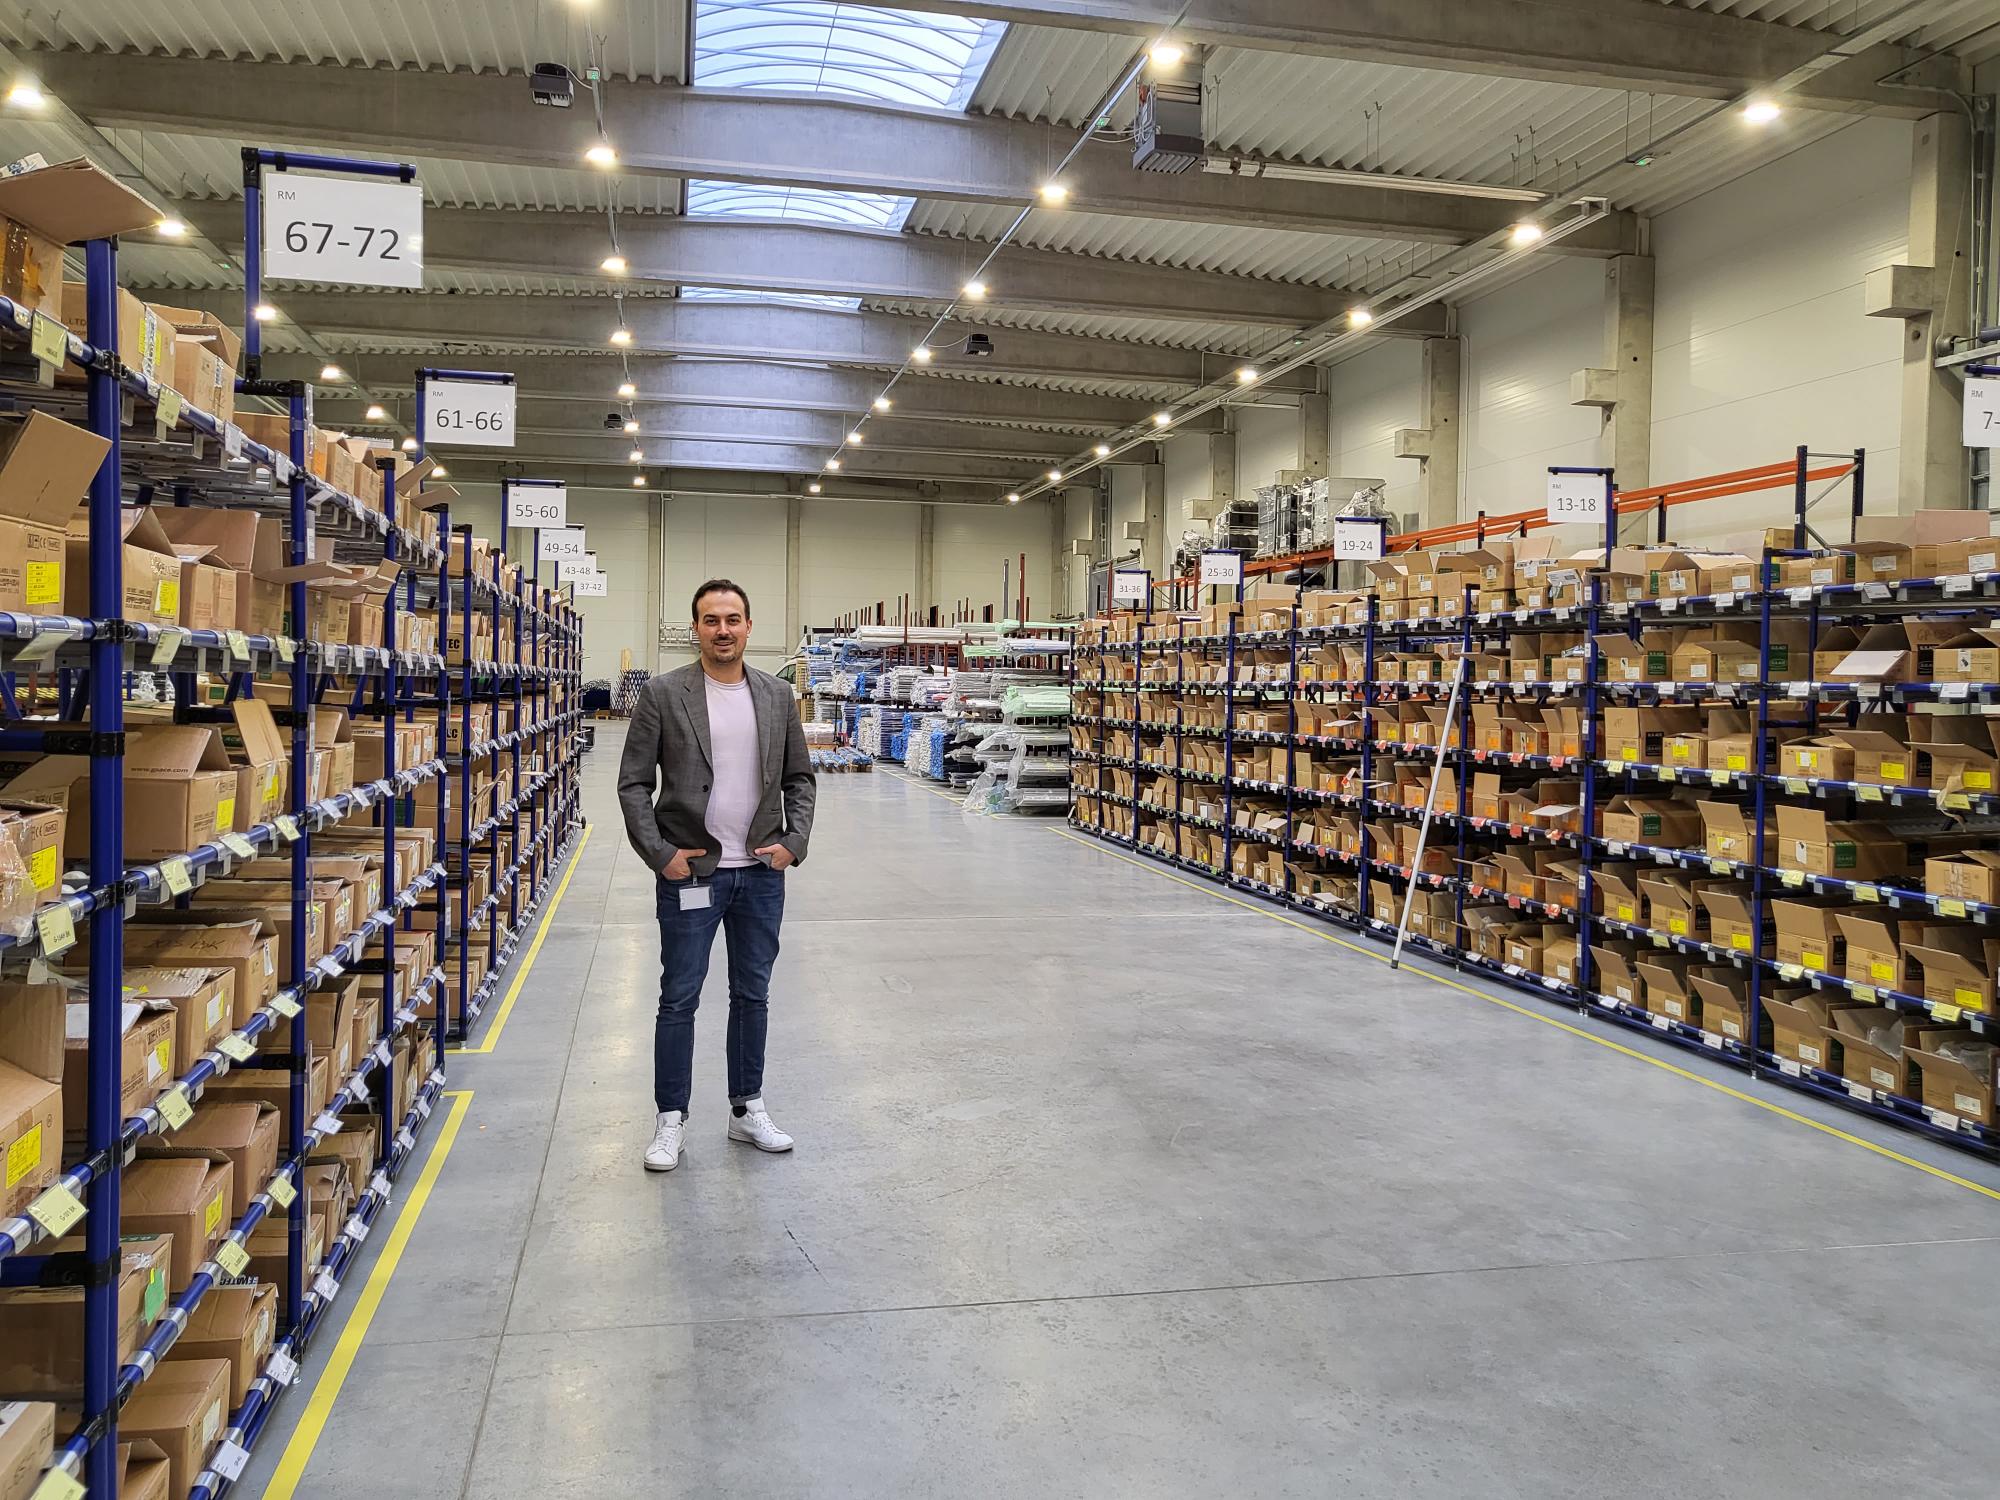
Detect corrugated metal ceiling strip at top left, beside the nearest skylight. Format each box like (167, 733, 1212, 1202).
(0, 0, 688, 84)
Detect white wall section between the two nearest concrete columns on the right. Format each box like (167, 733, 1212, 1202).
(1652, 120, 1912, 540)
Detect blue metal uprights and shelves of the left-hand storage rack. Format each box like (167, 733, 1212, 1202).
(0, 164, 582, 1500)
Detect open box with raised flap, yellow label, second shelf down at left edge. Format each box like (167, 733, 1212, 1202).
(0, 412, 110, 616)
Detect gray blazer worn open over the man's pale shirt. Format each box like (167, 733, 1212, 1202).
(618, 662, 816, 878)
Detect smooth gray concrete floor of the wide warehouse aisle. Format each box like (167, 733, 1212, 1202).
(248, 726, 2000, 1500)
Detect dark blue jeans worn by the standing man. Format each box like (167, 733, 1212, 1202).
(652, 864, 784, 1114)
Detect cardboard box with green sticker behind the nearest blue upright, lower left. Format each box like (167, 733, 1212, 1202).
(0, 1234, 174, 1402)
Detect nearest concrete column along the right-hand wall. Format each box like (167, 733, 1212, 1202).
(1896, 114, 1972, 514)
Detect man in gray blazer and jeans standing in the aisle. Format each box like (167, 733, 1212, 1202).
(618, 578, 814, 1172)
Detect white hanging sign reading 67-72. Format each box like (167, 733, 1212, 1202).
(264, 172, 424, 288)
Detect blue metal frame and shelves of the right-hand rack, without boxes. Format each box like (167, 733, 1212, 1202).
(1072, 450, 2000, 1158)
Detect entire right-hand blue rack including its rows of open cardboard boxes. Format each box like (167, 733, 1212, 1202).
(1072, 452, 2000, 1156)
